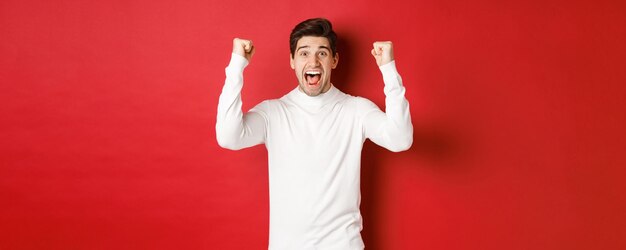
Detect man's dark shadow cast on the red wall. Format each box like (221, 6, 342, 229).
(333, 30, 469, 249)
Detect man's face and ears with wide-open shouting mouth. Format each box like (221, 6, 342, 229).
(290, 36, 339, 96)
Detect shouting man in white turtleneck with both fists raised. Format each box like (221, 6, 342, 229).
(216, 18, 413, 250)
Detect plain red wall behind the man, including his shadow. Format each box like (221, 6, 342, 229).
(0, 0, 626, 249)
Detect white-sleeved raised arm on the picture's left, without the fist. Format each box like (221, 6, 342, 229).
(215, 53, 265, 150)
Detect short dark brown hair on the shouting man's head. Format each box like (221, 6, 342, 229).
(289, 18, 337, 57)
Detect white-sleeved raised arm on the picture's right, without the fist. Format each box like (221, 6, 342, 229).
(363, 61, 413, 152)
